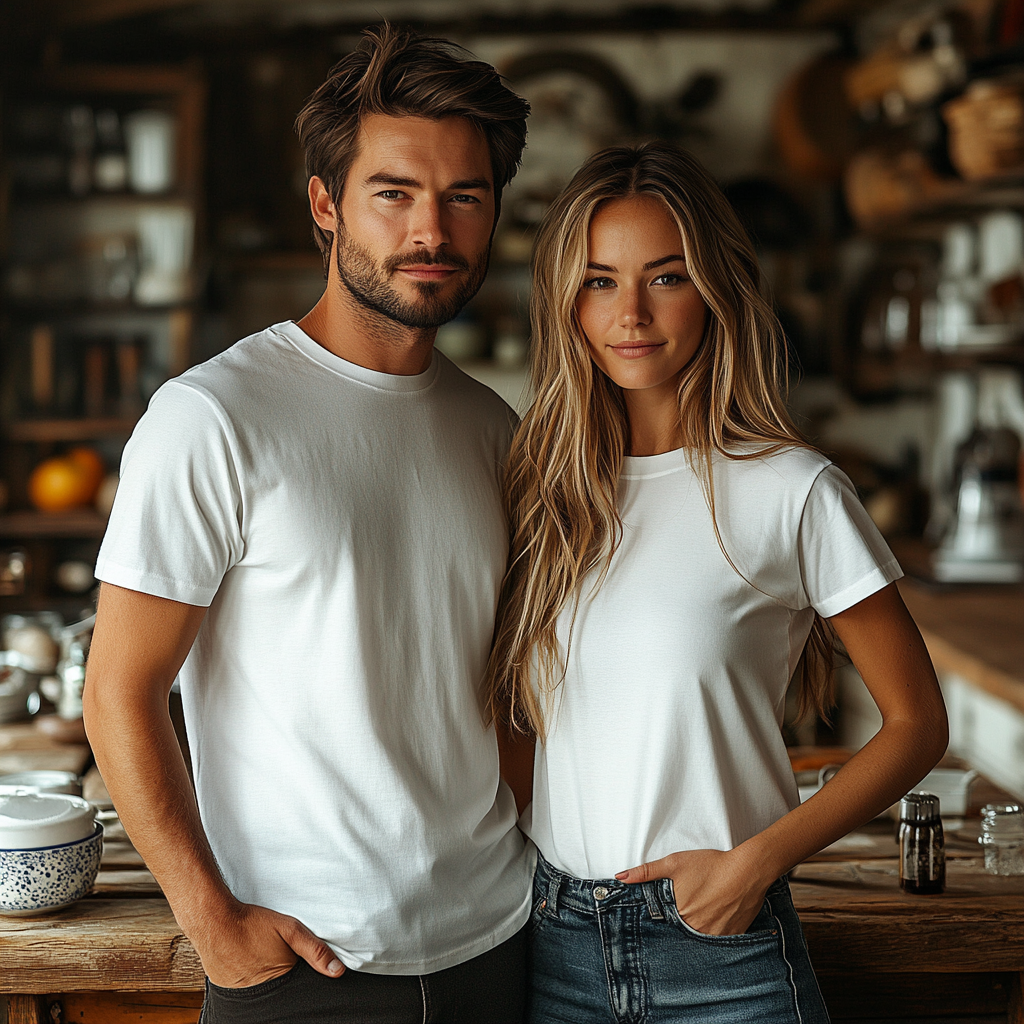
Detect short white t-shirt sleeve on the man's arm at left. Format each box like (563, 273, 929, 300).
(96, 381, 244, 607)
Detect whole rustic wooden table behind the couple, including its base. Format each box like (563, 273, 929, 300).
(6, 835, 1024, 1024)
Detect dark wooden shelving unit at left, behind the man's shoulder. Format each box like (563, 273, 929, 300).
(0, 66, 206, 611)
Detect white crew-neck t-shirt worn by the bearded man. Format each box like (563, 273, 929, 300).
(96, 323, 532, 975)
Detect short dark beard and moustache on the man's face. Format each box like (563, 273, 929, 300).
(335, 225, 489, 330)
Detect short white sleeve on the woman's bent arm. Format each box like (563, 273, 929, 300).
(798, 466, 903, 618)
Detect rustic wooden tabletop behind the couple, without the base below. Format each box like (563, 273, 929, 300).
(0, 858, 1024, 993)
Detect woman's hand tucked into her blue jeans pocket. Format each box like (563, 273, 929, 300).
(615, 850, 773, 935)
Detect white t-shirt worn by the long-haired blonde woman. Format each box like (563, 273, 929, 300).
(522, 449, 902, 879)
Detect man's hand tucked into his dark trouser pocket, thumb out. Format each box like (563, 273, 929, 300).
(192, 903, 345, 988)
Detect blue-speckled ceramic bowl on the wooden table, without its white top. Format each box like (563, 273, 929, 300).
(0, 824, 103, 918)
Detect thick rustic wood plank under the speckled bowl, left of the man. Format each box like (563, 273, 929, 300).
(0, 897, 204, 993)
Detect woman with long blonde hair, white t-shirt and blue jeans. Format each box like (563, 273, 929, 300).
(487, 143, 947, 1024)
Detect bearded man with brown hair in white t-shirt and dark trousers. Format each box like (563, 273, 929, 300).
(85, 29, 532, 1024)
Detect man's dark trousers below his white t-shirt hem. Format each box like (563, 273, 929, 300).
(200, 929, 526, 1024)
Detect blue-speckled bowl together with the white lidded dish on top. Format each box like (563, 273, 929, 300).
(0, 787, 103, 916)
